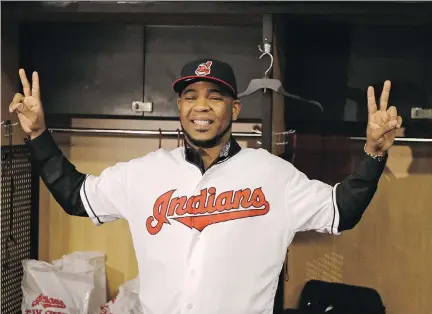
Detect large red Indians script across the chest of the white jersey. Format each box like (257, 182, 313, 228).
(146, 187, 270, 235)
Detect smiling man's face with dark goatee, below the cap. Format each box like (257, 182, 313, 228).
(177, 81, 241, 147)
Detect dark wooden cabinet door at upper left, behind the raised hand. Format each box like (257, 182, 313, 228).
(21, 23, 144, 116)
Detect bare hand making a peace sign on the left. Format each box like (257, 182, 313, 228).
(9, 69, 46, 139)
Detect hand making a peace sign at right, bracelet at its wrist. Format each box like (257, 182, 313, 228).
(365, 81, 402, 156)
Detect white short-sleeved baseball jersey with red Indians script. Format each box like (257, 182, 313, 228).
(81, 140, 339, 314)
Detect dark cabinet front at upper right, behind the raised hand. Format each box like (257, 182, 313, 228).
(280, 20, 432, 136)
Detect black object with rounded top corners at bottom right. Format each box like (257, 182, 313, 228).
(299, 280, 386, 314)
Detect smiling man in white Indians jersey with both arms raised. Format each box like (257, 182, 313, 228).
(10, 59, 402, 314)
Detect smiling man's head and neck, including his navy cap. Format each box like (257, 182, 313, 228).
(173, 59, 241, 171)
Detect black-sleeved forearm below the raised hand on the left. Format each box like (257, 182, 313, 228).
(26, 130, 88, 217)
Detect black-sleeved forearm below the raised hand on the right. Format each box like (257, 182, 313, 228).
(336, 154, 387, 231)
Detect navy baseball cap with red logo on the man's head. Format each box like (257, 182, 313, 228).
(172, 58, 237, 98)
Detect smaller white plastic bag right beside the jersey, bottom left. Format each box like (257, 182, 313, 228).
(94, 278, 144, 314)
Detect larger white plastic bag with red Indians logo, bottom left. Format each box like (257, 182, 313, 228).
(21, 252, 106, 314)
